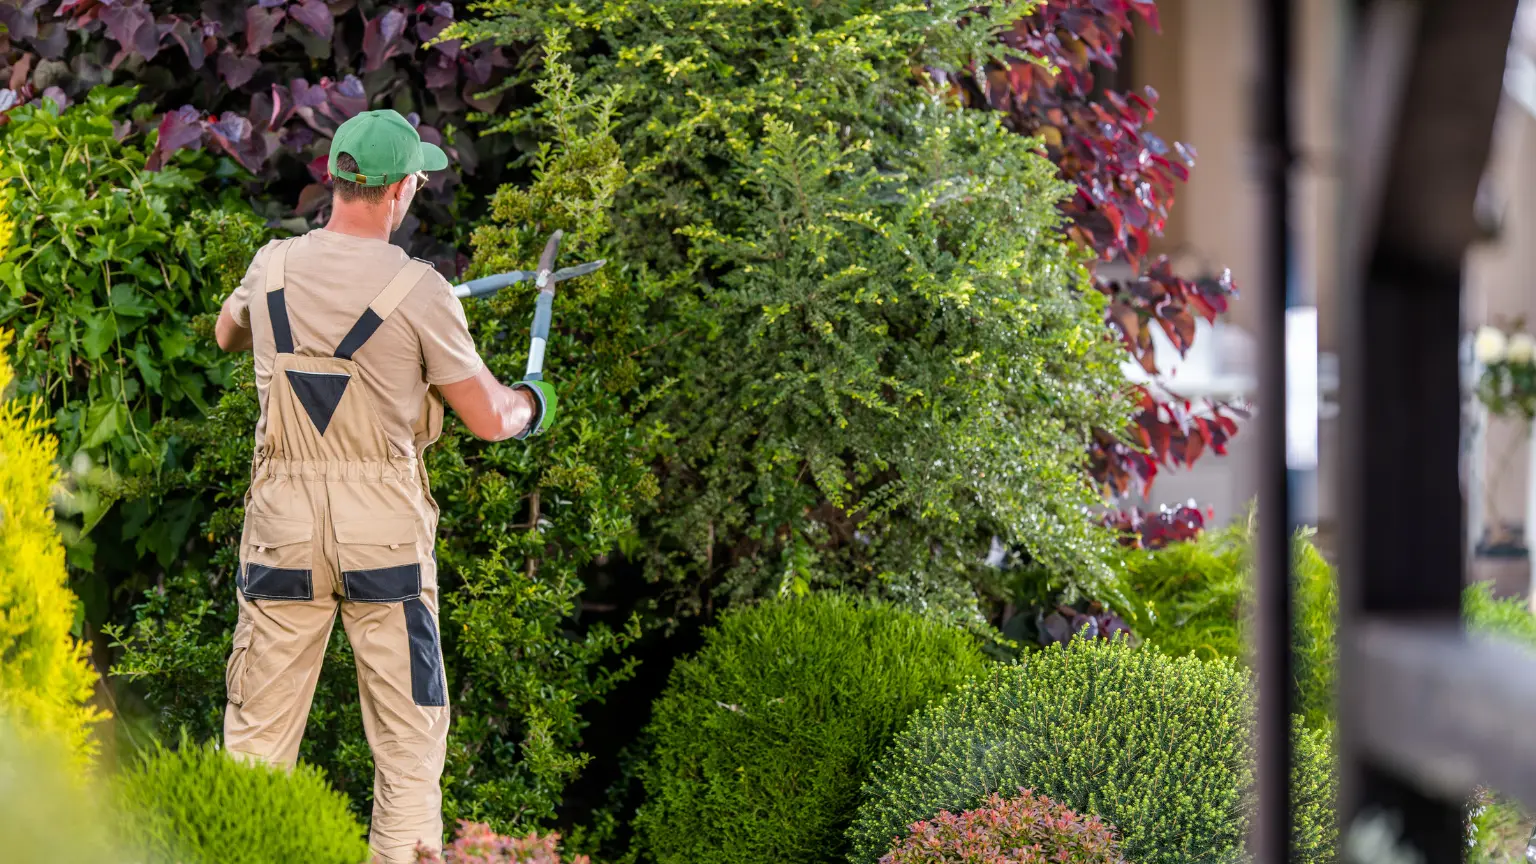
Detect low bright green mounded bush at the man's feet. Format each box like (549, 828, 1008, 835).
(115, 739, 369, 864)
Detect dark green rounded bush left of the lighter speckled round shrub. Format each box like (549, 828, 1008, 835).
(634, 595, 988, 864)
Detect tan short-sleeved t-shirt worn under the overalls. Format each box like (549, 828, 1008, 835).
(224, 228, 482, 458)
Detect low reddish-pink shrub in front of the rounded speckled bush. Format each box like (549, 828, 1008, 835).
(880, 790, 1124, 864)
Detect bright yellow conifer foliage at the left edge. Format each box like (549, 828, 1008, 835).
(0, 325, 103, 767)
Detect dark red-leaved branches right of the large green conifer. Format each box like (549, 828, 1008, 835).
(962, 0, 1241, 531)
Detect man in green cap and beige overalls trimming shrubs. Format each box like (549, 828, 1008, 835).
(217, 111, 553, 862)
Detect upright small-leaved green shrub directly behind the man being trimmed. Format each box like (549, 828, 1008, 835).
(114, 53, 656, 830)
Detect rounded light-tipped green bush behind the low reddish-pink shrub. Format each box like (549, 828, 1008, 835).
(848, 640, 1336, 864)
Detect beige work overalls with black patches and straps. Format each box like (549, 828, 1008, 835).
(224, 235, 449, 862)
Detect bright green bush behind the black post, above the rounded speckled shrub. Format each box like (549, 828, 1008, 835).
(1123, 517, 1338, 729)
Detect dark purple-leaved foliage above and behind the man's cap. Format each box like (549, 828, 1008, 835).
(0, 0, 511, 272)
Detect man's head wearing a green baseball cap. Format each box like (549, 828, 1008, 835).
(330, 109, 449, 232)
